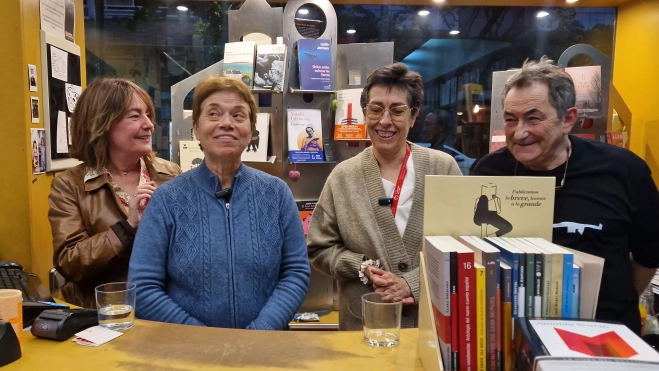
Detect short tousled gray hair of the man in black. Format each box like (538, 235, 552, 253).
(503, 56, 577, 118)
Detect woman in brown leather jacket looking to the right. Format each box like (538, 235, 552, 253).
(48, 78, 181, 308)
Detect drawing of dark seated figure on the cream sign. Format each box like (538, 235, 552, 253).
(474, 183, 513, 238)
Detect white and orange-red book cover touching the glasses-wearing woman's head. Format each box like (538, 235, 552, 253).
(334, 89, 367, 140)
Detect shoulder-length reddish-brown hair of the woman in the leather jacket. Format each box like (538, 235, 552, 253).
(69, 78, 155, 170)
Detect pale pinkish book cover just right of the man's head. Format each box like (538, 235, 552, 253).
(565, 66, 602, 117)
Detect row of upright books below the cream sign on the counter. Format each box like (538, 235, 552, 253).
(424, 236, 604, 370)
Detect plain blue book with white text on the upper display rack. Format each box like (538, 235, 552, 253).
(297, 39, 334, 91)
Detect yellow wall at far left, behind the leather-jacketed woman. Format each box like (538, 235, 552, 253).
(0, 0, 86, 285)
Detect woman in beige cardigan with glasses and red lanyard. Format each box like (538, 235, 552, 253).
(307, 63, 461, 330)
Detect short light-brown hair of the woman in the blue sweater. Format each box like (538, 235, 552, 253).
(192, 76, 259, 131)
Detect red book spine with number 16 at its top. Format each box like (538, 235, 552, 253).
(457, 252, 476, 371)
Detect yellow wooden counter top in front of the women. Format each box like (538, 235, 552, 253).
(7, 320, 423, 371)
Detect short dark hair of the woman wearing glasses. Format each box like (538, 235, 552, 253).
(360, 63, 423, 115)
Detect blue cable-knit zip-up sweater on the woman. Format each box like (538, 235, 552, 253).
(128, 162, 311, 330)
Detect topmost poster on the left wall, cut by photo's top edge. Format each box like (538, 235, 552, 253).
(39, 0, 75, 42)
